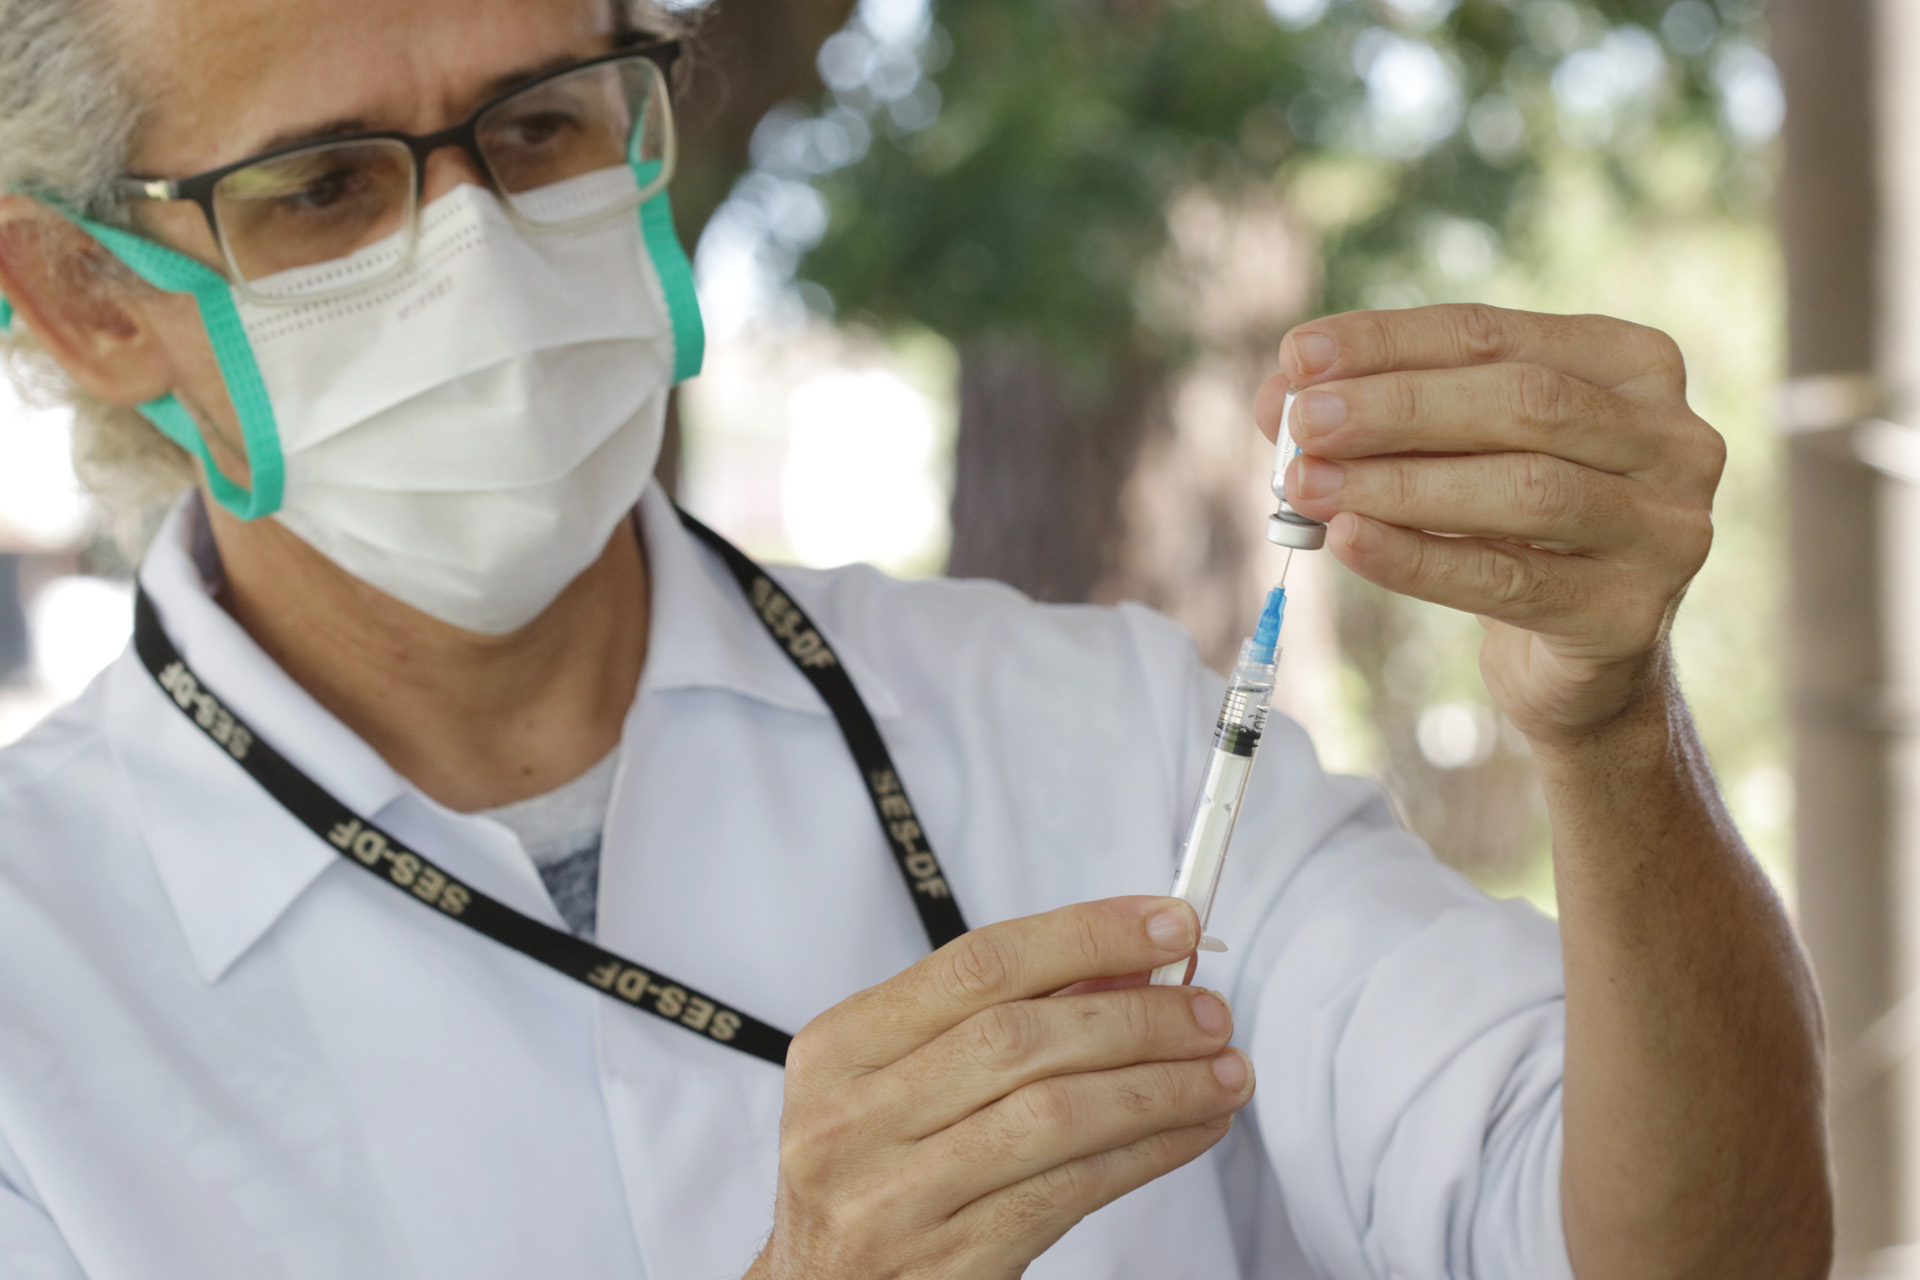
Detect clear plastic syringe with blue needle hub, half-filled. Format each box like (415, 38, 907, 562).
(1152, 587, 1286, 986)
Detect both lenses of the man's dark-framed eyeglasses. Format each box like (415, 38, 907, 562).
(213, 58, 672, 296)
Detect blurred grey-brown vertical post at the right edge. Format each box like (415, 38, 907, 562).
(1770, 0, 1920, 1280)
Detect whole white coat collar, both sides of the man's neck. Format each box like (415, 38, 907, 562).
(106, 487, 900, 983)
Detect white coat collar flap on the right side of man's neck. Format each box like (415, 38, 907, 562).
(639, 486, 900, 720)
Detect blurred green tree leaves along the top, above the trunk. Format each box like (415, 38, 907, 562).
(775, 0, 1759, 367)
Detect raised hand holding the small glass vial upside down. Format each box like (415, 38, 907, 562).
(1256, 305, 1726, 745)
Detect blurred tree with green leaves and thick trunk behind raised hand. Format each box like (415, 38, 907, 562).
(729, 0, 1772, 882)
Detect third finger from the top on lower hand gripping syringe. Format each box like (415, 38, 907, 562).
(914, 1050, 1254, 1205)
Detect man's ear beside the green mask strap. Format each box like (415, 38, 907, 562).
(0, 196, 177, 405)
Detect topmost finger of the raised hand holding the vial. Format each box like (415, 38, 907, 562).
(1281, 303, 1686, 391)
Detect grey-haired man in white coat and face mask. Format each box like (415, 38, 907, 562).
(0, 0, 1832, 1280)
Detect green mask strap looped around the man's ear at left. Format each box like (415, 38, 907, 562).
(0, 215, 286, 520)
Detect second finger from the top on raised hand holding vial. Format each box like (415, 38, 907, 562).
(1286, 363, 1676, 474)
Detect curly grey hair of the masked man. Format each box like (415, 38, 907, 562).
(0, 0, 678, 551)
